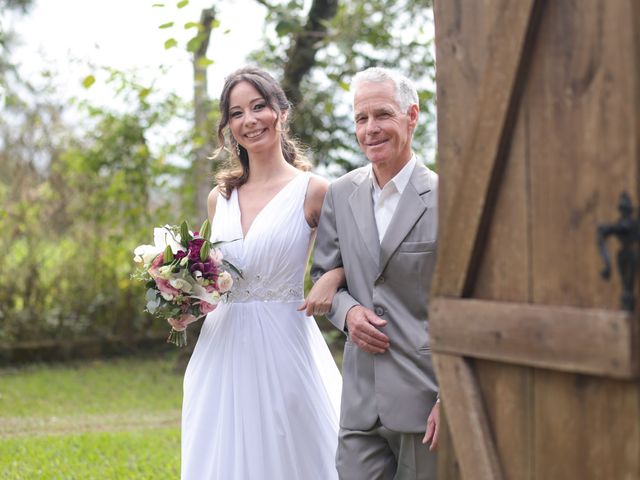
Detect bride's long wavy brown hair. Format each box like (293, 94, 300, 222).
(216, 67, 311, 198)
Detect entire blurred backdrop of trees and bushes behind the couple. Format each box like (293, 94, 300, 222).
(0, 0, 435, 352)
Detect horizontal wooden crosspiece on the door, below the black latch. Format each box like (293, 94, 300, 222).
(429, 297, 638, 378)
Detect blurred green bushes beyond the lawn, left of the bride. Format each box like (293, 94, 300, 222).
(0, 63, 189, 342)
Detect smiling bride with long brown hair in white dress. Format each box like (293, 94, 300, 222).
(175, 67, 344, 480)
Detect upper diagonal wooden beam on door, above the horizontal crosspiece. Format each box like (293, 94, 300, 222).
(433, 0, 544, 297)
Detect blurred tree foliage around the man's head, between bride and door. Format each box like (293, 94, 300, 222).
(251, 0, 435, 173)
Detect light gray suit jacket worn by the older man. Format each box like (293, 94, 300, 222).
(311, 161, 438, 433)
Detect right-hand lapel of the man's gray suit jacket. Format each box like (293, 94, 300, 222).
(379, 163, 431, 273)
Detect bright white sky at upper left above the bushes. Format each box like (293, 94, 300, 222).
(4, 0, 265, 102)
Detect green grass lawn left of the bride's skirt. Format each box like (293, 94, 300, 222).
(0, 354, 182, 480)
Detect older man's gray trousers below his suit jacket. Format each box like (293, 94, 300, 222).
(336, 421, 436, 480)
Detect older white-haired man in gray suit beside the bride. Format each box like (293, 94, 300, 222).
(312, 68, 439, 480)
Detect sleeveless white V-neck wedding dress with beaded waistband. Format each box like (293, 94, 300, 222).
(181, 174, 342, 480)
